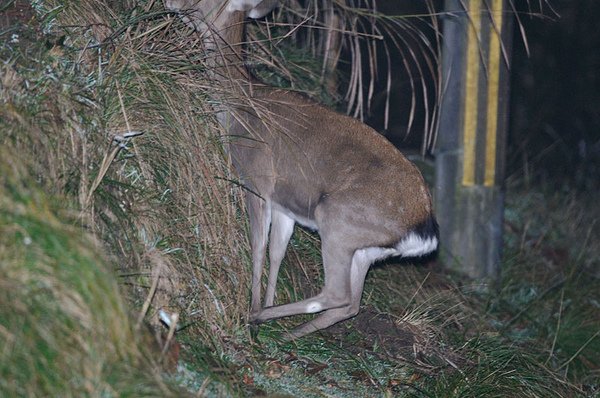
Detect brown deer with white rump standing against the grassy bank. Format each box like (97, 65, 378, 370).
(165, 0, 439, 340)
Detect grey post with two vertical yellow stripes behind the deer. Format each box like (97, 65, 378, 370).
(435, 0, 512, 280)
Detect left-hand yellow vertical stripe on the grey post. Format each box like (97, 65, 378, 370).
(462, 0, 481, 186)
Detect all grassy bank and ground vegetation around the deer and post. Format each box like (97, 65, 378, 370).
(0, 0, 600, 397)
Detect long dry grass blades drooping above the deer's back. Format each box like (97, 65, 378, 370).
(249, 0, 442, 149)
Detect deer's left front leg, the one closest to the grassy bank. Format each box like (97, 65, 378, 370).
(246, 193, 271, 318)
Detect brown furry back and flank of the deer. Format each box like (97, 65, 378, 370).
(232, 88, 431, 237)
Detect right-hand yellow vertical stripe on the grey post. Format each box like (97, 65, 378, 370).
(483, 0, 503, 187)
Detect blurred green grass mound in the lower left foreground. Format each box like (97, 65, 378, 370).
(0, 150, 182, 397)
